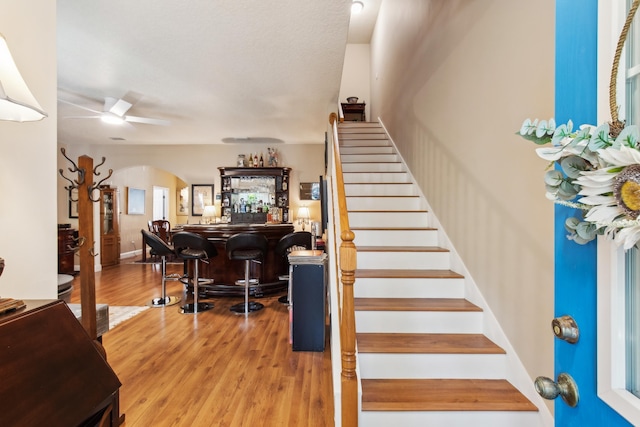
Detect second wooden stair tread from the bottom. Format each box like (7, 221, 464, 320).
(356, 333, 505, 354)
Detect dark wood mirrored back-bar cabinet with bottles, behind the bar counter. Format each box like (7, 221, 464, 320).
(218, 167, 291, 224)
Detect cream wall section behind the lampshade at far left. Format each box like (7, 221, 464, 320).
(0, 0, 58, 299)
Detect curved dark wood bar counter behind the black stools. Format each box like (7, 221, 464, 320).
(172, 224, 293, 296)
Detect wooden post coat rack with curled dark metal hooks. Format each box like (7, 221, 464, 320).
(58, 148, 113, 340)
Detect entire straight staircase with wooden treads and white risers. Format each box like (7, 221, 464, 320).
(338, 122, 543, 427)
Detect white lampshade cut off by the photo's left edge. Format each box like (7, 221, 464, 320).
(0, 34, 47, 122)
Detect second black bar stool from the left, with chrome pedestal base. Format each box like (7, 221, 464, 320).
(172, 231, 218, 314)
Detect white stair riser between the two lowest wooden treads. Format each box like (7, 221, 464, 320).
(358, 353, 507, 379)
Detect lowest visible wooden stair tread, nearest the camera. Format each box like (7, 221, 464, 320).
(362, 379, 538, 411)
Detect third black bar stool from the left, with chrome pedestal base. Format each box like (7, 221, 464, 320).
(225, 233, 269, 316)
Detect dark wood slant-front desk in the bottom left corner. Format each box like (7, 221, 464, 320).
(0, 300, 122, 427)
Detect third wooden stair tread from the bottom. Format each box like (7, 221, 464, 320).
(354, 298, 482, 312)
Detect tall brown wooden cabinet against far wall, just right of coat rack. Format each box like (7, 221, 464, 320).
(100, 187, 120, 267)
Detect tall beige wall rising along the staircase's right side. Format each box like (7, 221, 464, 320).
(371, 0, 555, 388)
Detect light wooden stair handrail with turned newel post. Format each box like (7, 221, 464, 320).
(329, 113, 358, 427)
